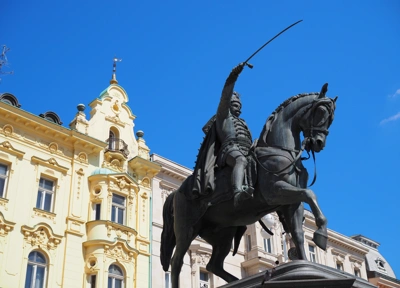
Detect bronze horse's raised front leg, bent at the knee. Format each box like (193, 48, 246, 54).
(267, 180, 328, 250)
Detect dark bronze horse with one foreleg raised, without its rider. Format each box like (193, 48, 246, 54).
(161, 83, 337, 288)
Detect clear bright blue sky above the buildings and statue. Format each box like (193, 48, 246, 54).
(0, 0, 400, 278)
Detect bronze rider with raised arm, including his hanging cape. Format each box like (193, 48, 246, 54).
(189, 63, 254, 207)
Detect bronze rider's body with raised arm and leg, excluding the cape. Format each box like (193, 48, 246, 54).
(216, 63, 253, 207)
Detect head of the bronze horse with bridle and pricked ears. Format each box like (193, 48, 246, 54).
(300, 83, 337, 152)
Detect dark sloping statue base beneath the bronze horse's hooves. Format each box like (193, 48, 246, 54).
(219, 260, 376, 288)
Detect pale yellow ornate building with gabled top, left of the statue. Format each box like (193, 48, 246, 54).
(0, 74, 160, 288)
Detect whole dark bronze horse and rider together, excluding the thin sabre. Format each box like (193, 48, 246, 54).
(161, 63, 336, 288)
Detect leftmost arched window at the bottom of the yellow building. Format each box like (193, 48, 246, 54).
(25, 251, 47, 288)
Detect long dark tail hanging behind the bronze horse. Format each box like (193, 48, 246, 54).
(160, 192, 176, 271)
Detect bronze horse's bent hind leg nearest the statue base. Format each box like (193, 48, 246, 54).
(206, 227, 238, 283)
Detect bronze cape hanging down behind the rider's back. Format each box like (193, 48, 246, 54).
(185, 115, 221, 199)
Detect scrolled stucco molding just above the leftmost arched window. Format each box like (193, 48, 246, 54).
(21, 223, 63, 250)
